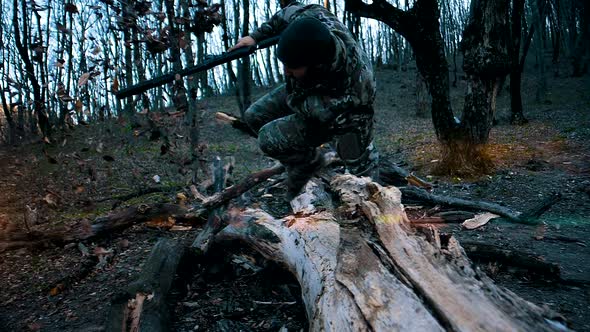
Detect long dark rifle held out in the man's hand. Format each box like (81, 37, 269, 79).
(115, 36, 280, 99)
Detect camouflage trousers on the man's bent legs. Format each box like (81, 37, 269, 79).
(244, 85, 379, 175)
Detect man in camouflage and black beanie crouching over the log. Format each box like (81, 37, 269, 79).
(232, 1, 378, 199)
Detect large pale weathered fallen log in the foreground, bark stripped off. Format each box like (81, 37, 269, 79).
(215, 175, 565, 331)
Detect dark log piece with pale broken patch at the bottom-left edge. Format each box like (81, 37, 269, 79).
(105, 239, 183, 332)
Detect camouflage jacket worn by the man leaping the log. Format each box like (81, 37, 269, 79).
(250, 2, 375, 122)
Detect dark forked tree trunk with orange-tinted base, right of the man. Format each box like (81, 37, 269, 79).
(346, 0, 509, 174)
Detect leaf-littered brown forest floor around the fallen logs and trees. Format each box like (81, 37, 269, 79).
(0, 69, 590, 331)
